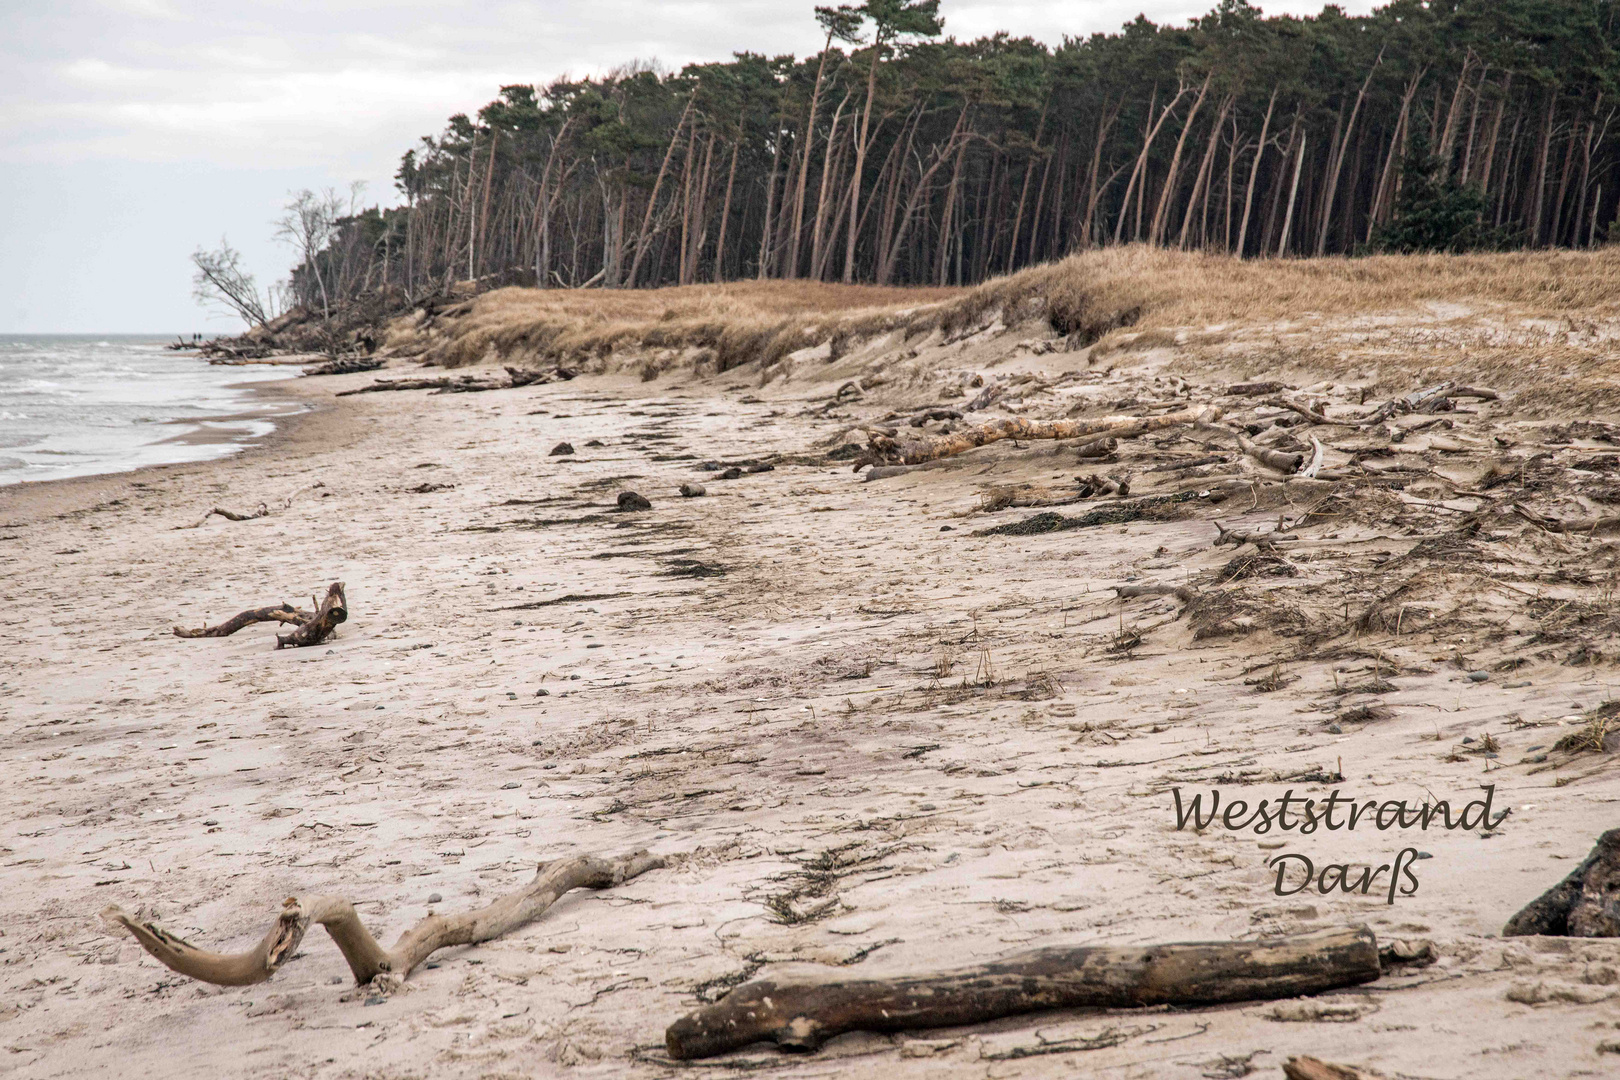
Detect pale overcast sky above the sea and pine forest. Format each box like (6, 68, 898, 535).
(0, 0, 1372, 334)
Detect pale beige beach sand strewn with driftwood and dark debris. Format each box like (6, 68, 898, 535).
(0, 323, 1620, 1078)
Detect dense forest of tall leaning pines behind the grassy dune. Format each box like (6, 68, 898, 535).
(239, 0, 1620, 317)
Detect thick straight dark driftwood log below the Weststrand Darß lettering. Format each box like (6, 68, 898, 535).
(664, 926, 1379, 1061)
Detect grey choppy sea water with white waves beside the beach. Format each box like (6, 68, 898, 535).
(0, 334, 298, 484)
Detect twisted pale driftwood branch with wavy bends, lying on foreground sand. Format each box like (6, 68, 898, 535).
(102, 852, 664, 986)
